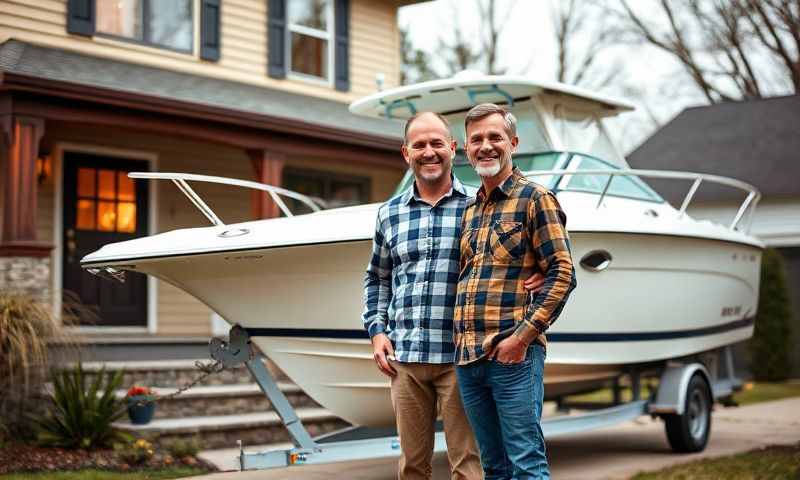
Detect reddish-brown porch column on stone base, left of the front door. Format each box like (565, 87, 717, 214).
(0, 116, 53, 298)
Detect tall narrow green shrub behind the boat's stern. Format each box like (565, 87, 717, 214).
(750, 248, 792, 382)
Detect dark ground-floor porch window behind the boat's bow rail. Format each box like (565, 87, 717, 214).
(283, 168, 370, 213)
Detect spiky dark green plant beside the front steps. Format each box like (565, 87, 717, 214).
(34, 362, 131, 450)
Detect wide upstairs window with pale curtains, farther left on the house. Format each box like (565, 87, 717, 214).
(96, 0, 194, 52)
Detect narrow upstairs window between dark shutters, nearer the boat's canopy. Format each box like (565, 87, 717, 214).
(286, 0, 333, 80)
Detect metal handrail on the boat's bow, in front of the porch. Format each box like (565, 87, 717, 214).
(128, 172, 325, 226)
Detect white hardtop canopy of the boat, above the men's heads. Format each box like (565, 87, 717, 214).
(350, 71, 633, 168)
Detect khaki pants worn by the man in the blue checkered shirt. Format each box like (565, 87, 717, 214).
(392, 362, 483, 480)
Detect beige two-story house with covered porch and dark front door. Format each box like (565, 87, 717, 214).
(0, 0, 414, 352)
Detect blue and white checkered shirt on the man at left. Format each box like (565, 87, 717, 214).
(363, 178, 467, 363)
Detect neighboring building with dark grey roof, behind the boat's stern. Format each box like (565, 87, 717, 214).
(628, 95, 800, 376)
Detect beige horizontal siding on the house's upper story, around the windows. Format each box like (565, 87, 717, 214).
(0, 0, 400, 102)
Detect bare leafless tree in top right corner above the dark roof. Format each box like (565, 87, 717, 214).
(607, 0, 800, 103)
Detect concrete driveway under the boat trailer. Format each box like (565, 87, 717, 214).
(195, 398, 800, 480)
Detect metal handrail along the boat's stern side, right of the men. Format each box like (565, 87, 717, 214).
(523, 168, 761, 230)
